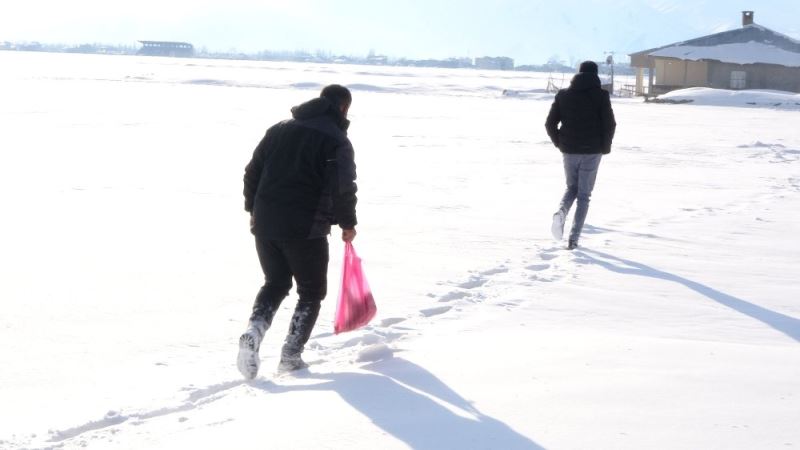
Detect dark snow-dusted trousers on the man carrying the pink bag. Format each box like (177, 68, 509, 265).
(250, 236, 329, 356)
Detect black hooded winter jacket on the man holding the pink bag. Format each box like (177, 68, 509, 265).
(244, 98, 357, 239)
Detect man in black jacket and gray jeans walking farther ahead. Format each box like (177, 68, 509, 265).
(545, 61, 617, 250)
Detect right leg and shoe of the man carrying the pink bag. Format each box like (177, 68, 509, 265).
(280, 238, 329, 370)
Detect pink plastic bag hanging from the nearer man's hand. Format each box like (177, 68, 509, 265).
(333, 242, 378, 334)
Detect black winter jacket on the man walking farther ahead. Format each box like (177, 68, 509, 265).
(544, 72, 617, 153)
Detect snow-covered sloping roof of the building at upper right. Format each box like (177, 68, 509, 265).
(639, 24, 800, 67)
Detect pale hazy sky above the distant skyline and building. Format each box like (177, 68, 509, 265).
(0, 0, 800, 65)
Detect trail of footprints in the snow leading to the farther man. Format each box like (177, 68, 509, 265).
(29, 247, 574, 449)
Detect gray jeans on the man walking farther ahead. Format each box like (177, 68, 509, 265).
(559, 153, 603, 242)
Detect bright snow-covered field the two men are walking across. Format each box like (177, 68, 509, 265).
(0, 52, 800, 450)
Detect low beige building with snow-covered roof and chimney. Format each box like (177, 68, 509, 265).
(630, 11, 800, 96)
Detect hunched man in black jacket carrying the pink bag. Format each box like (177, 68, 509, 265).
(237, 85, 356, 379)
